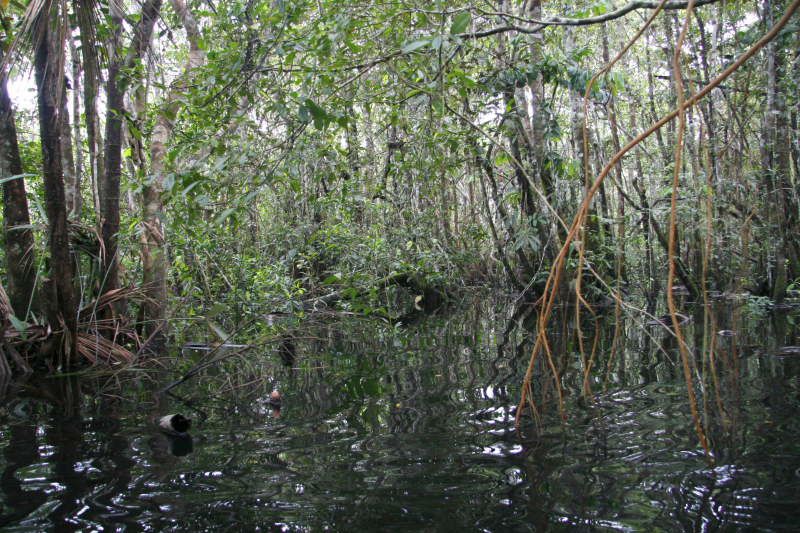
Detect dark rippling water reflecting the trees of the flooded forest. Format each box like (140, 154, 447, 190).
(0, 299, 800, 531)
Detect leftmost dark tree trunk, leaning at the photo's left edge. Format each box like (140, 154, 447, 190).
(0, 50, 36, 318)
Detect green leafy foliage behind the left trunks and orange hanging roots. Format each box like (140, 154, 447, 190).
(4, 0, 800, 362)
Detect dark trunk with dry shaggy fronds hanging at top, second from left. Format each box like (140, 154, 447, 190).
(34, 2, 77, 362)
